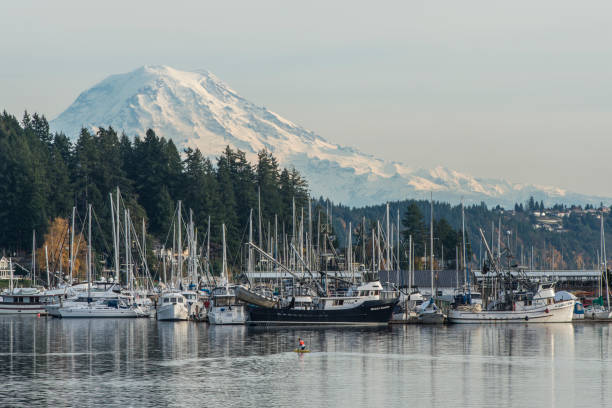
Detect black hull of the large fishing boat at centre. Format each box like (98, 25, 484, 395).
(247, 299, 397, 325)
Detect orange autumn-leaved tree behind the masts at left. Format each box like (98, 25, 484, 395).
(36, 217, 87, 280)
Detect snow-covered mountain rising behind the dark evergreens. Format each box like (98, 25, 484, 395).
(51, 66, 606, 206)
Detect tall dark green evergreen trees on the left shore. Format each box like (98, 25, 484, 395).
(0, 111, 308, 274)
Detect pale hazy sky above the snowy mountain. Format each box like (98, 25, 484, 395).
(0, 0, 612, 196)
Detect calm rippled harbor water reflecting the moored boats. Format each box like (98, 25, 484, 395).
(0, 316, 612, 407)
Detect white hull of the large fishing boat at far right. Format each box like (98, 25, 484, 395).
(448, 300, 574, 324)
